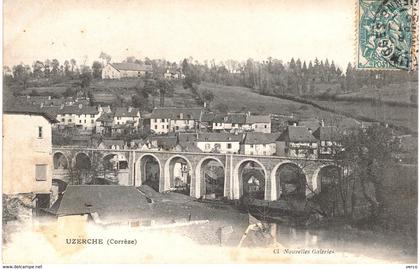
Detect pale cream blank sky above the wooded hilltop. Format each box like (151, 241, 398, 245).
(3, 0, 355, 68)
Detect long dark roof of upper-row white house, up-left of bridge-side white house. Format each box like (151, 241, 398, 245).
(150, 107, 202, 120)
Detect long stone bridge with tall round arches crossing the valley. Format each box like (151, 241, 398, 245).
(52, 147, 334, 201)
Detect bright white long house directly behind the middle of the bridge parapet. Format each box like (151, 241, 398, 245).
(196, 133, 243, 154)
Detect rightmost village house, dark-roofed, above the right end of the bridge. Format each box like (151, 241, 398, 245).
(313, 126, 340, 158)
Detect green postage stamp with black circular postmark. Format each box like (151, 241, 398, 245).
(356, 0, 418, 70)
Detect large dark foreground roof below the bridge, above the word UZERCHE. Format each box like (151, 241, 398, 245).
(57, 185, 150, 222)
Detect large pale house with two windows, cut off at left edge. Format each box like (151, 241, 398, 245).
(3, 102, 56, 211)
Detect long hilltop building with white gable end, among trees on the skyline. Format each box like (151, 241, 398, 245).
(102, 63, 153, 79)
